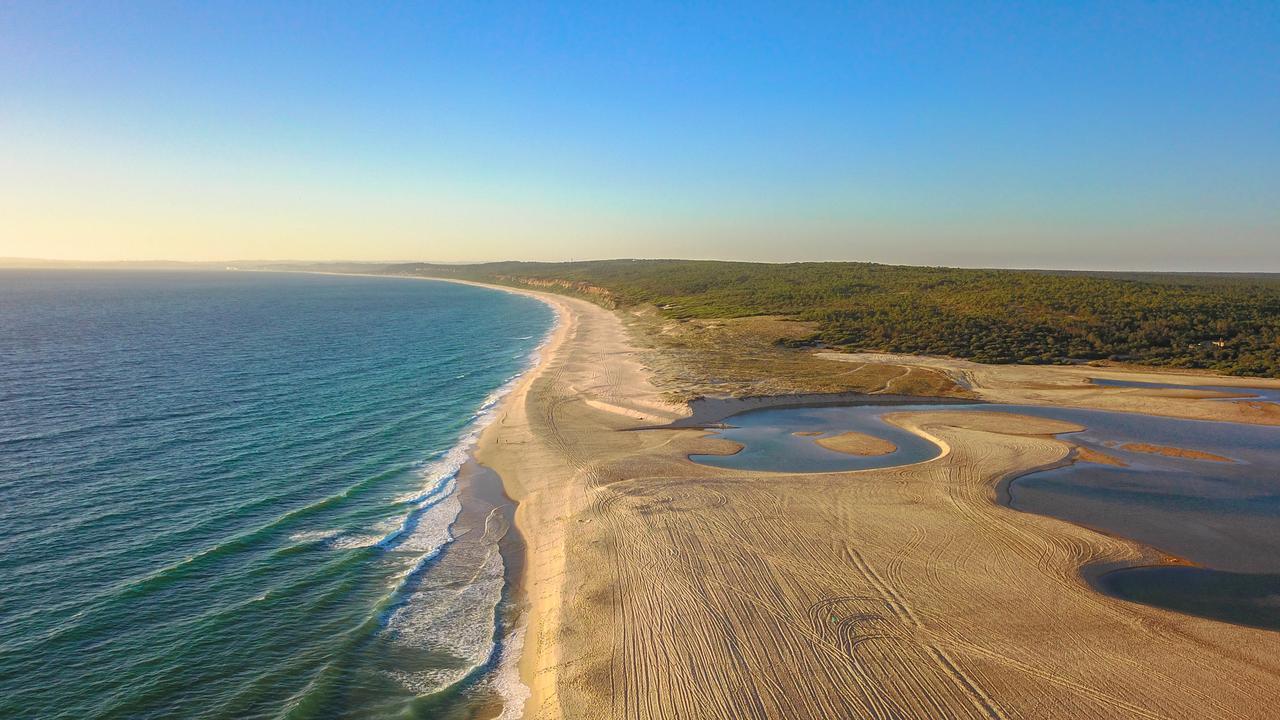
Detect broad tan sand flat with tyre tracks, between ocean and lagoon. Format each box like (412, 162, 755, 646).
(479, 288, 1280, 720)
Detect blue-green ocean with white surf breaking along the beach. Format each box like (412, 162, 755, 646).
(0, 270, 554, 719)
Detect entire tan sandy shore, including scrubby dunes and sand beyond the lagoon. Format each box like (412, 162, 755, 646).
(10, 260, 1280, 719)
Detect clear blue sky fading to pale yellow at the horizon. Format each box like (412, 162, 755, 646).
(0, 0, 1280, 272)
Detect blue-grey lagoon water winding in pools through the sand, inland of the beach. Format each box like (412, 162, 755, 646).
(692, 397, 1280, 629)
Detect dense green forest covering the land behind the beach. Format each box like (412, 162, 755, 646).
(392, 260, 1280, 377)
